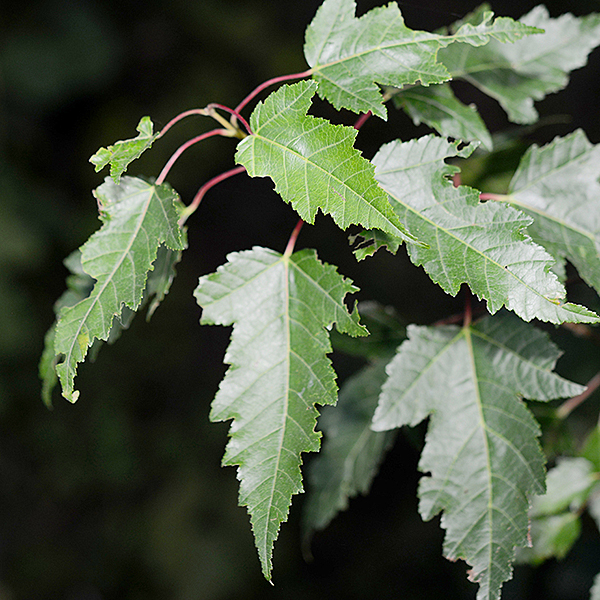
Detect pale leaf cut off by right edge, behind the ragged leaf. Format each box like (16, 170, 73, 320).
(506, 130, 600, 300)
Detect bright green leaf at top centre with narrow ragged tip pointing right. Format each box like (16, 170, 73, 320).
(304, 0, 536, 119)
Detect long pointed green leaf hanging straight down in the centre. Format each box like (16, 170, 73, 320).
(194, 248, 366, 579)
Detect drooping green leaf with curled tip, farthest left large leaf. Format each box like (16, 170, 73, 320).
(55, 177, 185, 402)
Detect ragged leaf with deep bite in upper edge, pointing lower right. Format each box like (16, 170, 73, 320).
(364, 136, 598, 323)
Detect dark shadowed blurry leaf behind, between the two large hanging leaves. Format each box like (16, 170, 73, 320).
(303, 357, 396, 539)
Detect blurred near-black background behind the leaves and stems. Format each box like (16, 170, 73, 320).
(0, 0, 600, 600)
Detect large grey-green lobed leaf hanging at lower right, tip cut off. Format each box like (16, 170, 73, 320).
(373, 313, 584, 600)
